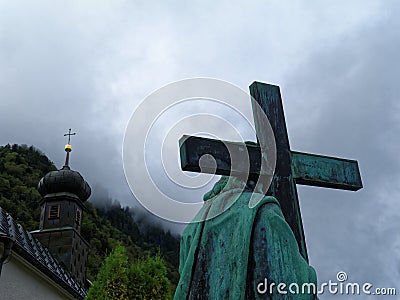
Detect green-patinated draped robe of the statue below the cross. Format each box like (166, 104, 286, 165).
(174, 177, 317, 300)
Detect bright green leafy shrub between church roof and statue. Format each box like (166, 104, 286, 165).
(86, 245, 172, 300)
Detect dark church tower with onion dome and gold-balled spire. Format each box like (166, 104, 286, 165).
(31, 129, 91, 285)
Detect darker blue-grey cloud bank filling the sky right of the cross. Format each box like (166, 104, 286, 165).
(285, 2, 400, 299)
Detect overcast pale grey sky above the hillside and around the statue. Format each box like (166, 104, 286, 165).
(0, 0, 400, 299)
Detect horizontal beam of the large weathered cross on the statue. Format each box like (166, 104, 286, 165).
(179, 135, 362, 191)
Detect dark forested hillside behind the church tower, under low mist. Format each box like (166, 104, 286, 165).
(0, 145, 179, 285)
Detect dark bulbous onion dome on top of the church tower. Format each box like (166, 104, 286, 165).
(38, 166, 91, 202)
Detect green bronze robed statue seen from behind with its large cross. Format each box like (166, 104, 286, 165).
(175, 82, 362, 300)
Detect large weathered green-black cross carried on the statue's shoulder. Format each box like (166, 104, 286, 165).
(180, 82, 362, 261)
